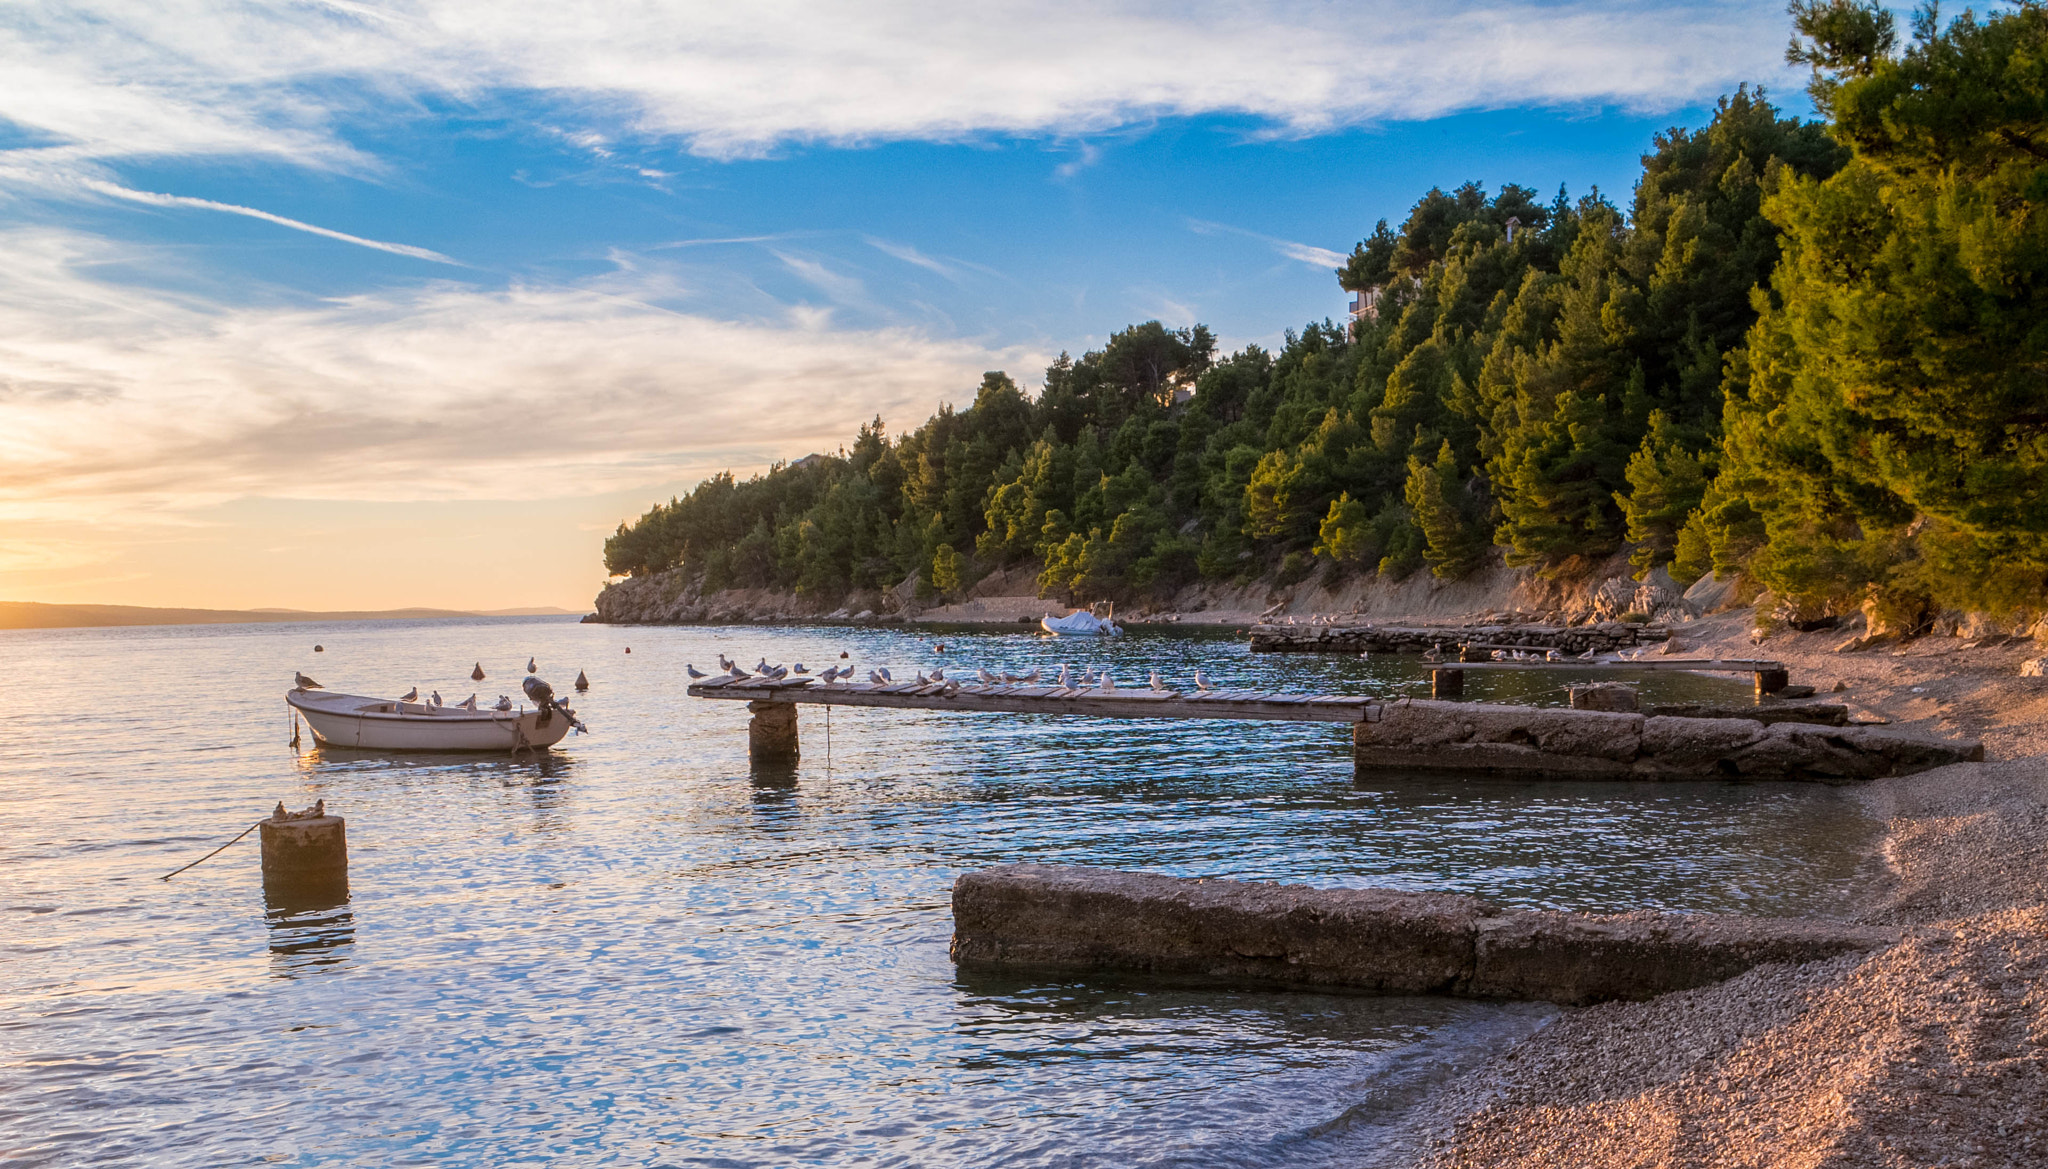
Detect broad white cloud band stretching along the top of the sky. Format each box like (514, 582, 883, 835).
(0, 0, 1788, 168)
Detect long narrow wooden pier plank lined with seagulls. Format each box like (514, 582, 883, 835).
(688, 678, 1380, 723)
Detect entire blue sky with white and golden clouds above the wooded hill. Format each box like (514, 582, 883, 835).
(0, 0, 1808, 608)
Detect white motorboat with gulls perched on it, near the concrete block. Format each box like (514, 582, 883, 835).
(285, 690, 575, 751)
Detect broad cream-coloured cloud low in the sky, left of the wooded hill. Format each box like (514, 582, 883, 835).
(0, 229, 1044, 522)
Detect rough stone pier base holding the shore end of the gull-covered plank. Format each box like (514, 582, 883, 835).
(1352, 698, 1985, 782)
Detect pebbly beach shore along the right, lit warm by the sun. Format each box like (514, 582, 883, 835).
(1386, 612, 2048, 1169)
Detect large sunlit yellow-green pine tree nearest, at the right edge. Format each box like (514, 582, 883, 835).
(1704, 0, 2048, 610)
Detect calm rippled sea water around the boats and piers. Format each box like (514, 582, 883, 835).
(0, 618, 1878, 1167)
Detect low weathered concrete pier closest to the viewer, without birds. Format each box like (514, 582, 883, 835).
(952, 864, 1898, 1005)
